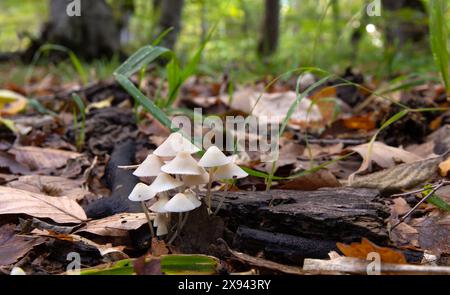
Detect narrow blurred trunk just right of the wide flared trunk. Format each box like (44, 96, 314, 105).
(159, 0, 184, 49)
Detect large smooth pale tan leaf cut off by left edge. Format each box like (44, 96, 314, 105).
(0, 186, 87, 223)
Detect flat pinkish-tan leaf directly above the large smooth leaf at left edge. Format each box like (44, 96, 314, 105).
(6, 175, 90, 201)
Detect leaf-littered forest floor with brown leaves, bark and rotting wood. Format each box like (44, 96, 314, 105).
(0, 65, 450, 274)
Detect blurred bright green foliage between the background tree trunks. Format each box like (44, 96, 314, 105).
(0, 0, 450, 82)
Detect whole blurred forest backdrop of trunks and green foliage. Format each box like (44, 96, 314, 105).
(0, 0, 448, 82)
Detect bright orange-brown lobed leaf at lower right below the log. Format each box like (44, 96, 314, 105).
(336, 238, 406, 264)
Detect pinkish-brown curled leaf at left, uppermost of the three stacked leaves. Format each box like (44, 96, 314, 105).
(9, 146, 81, 170)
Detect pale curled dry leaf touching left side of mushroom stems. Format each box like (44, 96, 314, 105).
(76, 213, 150, 237)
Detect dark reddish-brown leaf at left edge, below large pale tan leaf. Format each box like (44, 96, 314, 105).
(0, 224, 45, 265)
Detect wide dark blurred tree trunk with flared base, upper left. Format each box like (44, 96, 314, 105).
(24, 0, 120, 60)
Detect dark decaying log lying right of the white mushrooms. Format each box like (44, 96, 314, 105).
(213, 187, 389, 245)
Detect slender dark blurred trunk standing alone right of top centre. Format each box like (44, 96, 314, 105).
(258, 0, 280, 56)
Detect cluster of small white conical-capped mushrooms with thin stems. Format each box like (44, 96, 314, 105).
(128, 132, 247, 236)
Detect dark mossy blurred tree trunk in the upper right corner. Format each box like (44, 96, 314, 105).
(382, 0, 428, 47)
